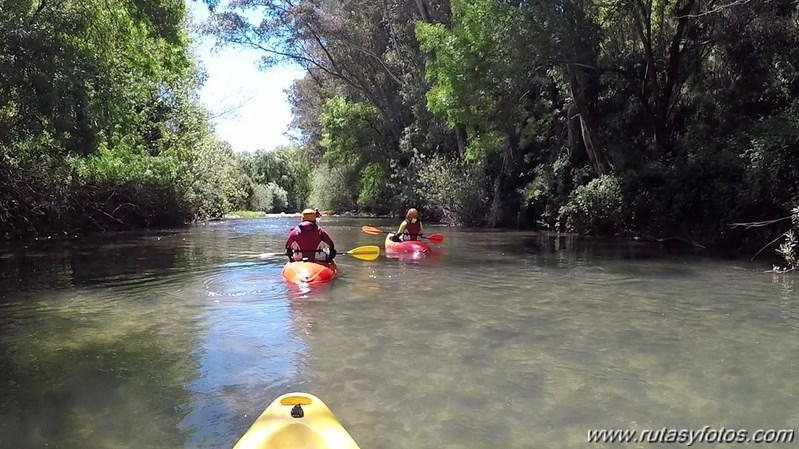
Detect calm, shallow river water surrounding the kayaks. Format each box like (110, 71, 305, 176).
(0, 217, 799, 449)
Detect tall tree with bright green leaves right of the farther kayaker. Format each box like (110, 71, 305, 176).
(417, 0, 541, 225)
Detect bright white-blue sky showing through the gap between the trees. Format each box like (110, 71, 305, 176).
(186, 0, 304, 152)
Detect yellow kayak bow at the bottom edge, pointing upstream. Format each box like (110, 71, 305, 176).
(233, 393, 360, 449)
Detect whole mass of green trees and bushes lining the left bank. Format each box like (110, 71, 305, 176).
(0, 0, 243, 238)
